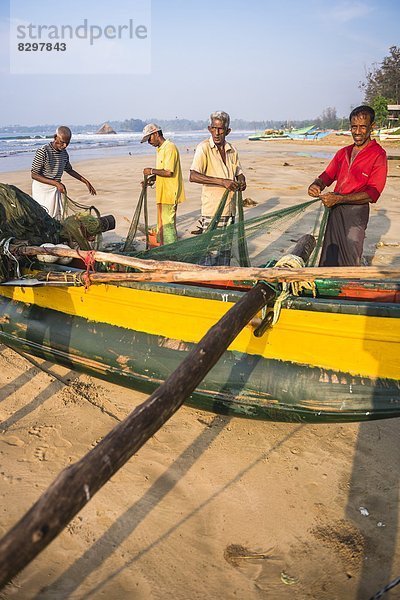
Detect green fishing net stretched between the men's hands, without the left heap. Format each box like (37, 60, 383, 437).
(123, 186, 326, 267)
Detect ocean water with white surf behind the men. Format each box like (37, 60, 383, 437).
(0, 130, 251, 173)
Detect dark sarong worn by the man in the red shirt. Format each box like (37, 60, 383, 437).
(319, 203, 369, 267)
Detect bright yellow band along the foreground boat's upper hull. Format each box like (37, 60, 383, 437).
(0, 284, 400, 380)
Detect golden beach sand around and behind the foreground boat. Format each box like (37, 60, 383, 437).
(0, 140, 400, 600)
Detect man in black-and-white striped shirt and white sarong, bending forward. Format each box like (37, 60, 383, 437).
(31, 126, 96, 220)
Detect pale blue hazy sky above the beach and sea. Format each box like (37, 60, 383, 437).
(0, 0, 400, 126)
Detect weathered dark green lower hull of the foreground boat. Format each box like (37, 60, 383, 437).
(0, 297, 400, 422)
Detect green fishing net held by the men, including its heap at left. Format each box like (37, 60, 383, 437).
(0, 184, 328, 280)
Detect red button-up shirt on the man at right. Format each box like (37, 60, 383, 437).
(319, 140, 387, 202)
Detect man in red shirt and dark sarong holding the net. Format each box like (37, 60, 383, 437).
(308, 106, 387, 267)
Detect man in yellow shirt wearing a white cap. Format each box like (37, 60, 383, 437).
(141, 123, 185, 245)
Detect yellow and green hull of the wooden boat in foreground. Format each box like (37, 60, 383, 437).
(0, 272, 400, 422)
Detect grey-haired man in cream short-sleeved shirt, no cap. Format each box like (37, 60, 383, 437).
(189, 111, 246, 266)
